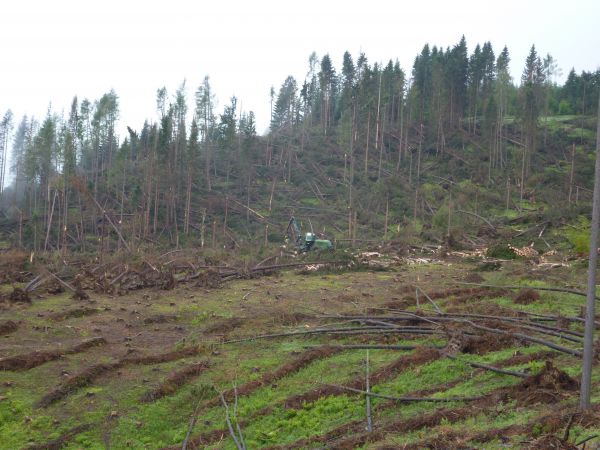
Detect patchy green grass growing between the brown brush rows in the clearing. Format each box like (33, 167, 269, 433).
(0, 260, 600, 449)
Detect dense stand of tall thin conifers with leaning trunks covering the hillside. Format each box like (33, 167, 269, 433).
(0, 37, 600, 250)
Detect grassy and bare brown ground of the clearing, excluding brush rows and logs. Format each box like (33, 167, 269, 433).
(0, 255, 600, 449)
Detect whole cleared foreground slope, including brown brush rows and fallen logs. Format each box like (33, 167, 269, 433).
(0, 258, 600, 449)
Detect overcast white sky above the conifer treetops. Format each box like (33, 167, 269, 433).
(0, 0, 600, 137)
